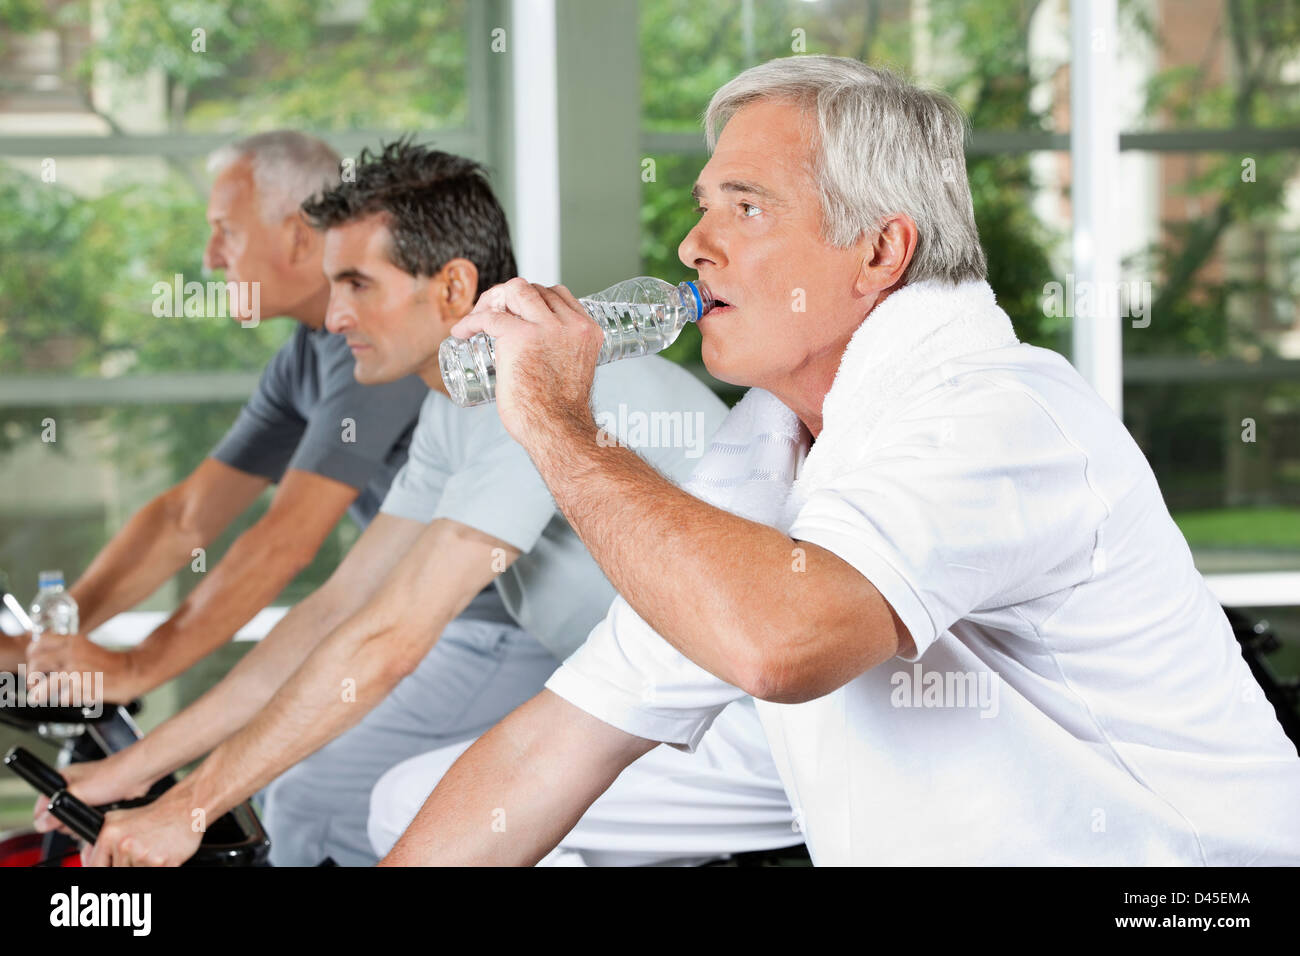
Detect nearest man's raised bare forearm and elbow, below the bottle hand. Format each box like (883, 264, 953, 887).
(529, 416, 914, 704)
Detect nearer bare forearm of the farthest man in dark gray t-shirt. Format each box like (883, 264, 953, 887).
(133, 519, 311, 691)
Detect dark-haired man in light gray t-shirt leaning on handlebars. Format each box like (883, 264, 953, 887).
(43, 143, 800, 865)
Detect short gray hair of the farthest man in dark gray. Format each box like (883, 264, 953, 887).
(208, 130, 339, 222)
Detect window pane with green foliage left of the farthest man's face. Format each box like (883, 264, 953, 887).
(0, 157, 291, 377)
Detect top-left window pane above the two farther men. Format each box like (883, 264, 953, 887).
(0, 0, 468, 135)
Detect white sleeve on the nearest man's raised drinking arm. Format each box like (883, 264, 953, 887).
(789, 385, 1108, 661)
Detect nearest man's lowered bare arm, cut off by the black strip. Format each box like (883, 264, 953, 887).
(380, 691, 657, 866)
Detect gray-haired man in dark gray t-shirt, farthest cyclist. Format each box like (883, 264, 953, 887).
(27, 130, 428, 702)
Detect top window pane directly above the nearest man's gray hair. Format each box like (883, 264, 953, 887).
(638, 0, 1070, 133)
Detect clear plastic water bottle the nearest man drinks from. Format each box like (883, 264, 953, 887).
(438, 276, 714, 408)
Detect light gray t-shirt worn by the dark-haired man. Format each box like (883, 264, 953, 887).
(381, 356, 727, 659)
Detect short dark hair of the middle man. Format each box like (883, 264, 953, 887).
(303, 139, 519, 295)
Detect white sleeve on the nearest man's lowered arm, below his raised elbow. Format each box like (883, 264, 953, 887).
(546, 597, 745, 753)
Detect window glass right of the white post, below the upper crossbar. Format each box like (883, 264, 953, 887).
(1123, 150, 1300, 572)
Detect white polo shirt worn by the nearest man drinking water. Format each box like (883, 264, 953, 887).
(547, 284, 1300, 865)
